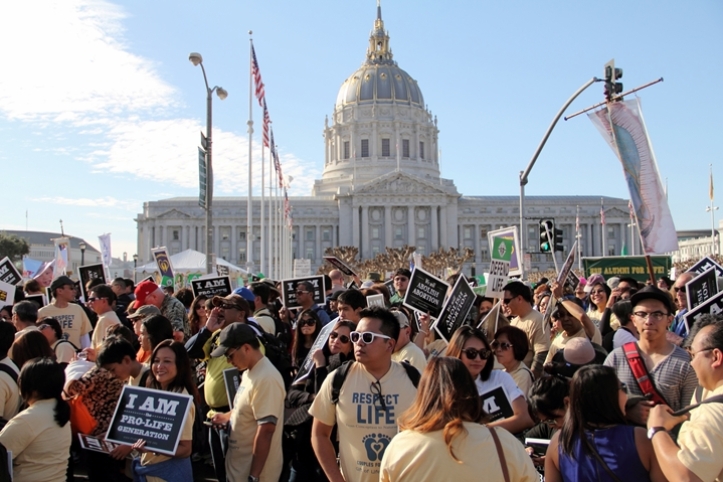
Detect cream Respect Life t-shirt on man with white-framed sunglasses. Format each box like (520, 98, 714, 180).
(309, 362, 418, 482)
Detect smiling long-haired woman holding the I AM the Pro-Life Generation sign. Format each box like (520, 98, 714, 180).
(133, 340, 199, 482)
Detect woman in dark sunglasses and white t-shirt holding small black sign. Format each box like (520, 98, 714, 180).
(447, 325, 534, 433)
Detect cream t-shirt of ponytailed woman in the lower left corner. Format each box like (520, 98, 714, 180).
(0, 399, 71, 482)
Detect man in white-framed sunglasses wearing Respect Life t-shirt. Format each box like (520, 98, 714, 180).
(309, 307, 417, 482)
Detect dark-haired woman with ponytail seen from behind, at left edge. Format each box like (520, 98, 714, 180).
(0, 357, 72, 482)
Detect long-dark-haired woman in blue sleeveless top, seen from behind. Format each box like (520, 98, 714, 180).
(545, 365, 666, 482)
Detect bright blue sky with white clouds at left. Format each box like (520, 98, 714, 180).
(0, 0, 723, 258)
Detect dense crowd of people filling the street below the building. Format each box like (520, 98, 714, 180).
(0, 268, 723, 482)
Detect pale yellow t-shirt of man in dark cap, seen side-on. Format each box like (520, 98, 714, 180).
(226, 357, 286, 482)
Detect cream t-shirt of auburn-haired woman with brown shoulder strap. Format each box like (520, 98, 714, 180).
(379, 422, 540, 482)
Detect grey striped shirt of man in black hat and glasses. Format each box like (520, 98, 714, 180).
(604, 346, 698, 410)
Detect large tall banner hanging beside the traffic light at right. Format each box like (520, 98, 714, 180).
(588, 98, 678, 254)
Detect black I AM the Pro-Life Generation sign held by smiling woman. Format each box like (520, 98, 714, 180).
(105, 385, 193, 456)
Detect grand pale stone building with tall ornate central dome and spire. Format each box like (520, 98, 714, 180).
(136, 5, 640, 274)
